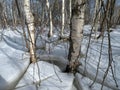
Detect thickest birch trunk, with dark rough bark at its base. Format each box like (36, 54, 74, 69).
(68, 0, 85, 73)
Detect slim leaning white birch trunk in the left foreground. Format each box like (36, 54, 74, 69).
(24, 0, 36, 63)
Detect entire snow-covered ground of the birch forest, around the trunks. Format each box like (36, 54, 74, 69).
(0, 25, 120, 90)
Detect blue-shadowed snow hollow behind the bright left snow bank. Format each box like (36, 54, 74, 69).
(3, 28, 27, 51)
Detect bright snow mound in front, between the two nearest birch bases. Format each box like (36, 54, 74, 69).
(15, 61, 75, 90)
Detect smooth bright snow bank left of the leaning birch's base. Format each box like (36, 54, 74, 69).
(0, 29, 29, 90)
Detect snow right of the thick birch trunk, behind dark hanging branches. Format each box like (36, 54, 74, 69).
(75, 25, 120, 90)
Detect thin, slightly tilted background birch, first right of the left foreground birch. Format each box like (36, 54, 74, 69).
(46, 0, 53, 37)
